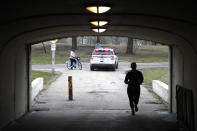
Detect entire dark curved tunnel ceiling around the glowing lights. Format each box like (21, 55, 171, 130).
(0, 0, 197, 51)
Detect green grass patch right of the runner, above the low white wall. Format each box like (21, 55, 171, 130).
(141, 69, 168, 84)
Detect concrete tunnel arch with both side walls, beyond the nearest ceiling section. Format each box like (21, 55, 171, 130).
(0, 1, 197, 130)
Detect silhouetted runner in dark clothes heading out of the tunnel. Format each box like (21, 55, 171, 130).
(124, 62, 144, 115)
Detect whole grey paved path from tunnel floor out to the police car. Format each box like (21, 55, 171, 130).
(2, 64, 176, 131)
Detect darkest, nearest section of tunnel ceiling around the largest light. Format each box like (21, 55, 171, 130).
(0, 0, 197, 24)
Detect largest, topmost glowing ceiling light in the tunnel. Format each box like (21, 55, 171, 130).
(86, 5, 111, 14)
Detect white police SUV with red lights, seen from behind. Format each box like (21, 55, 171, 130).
(90, 48, 118, 71)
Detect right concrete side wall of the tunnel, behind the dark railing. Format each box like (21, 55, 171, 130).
(171, 43, 197, 129)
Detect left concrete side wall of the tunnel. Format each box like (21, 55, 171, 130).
(0, 44, 28, 129)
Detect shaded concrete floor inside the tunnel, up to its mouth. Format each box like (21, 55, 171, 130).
(4, 110, 176, 131)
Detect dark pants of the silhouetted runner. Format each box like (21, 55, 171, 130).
(127, 86, 140, 109)
